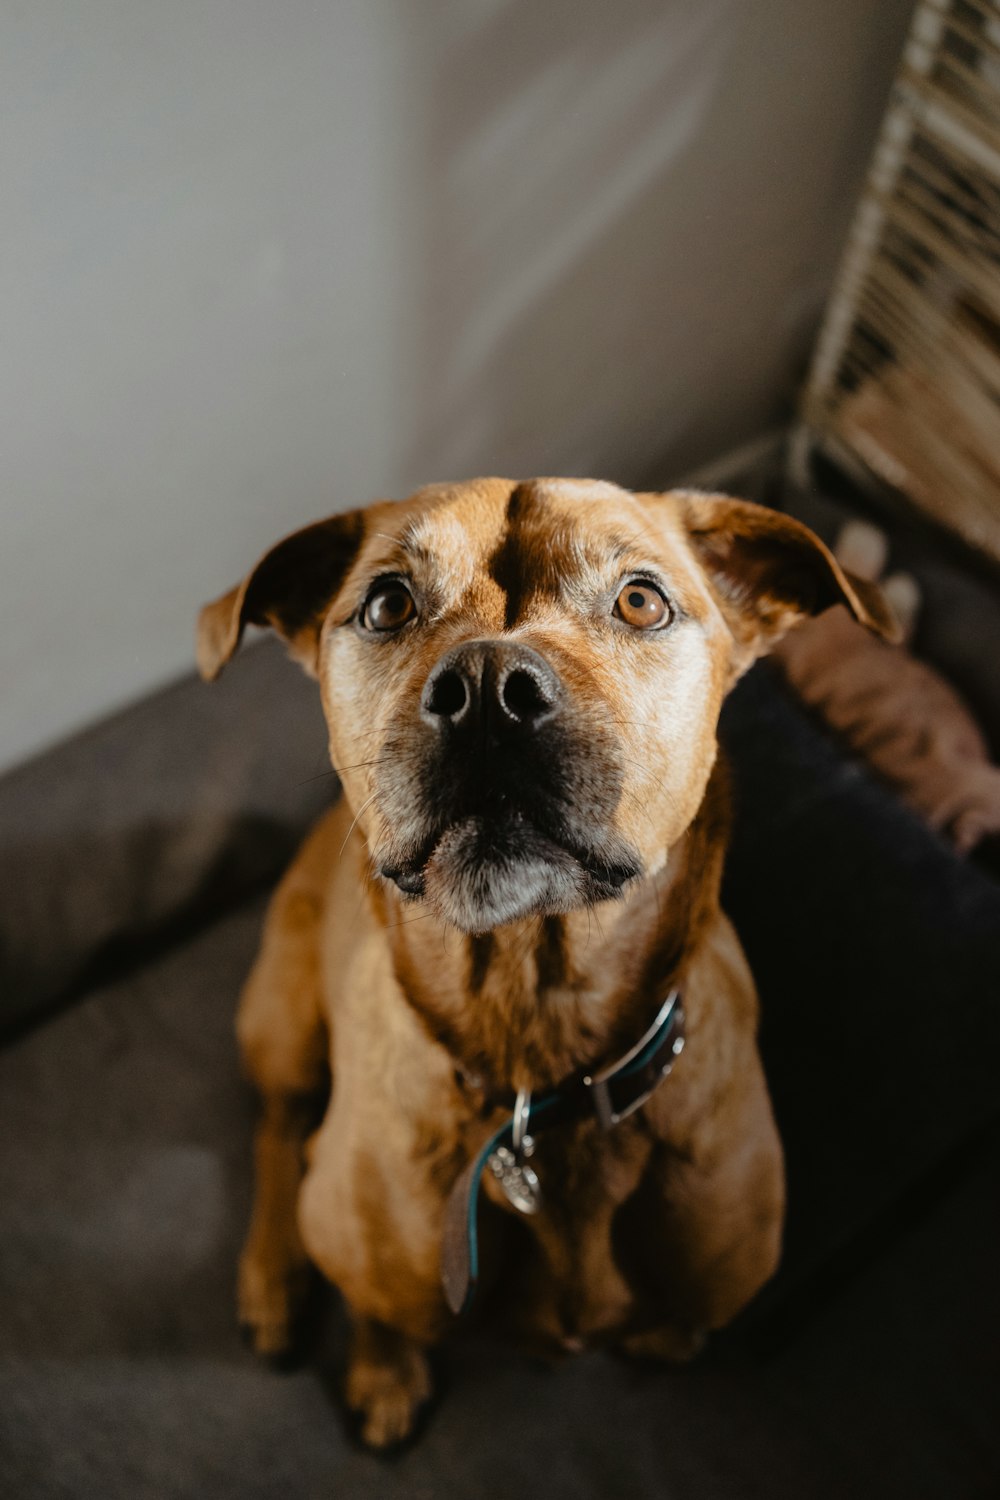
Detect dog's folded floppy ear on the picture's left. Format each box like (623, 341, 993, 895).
(196, 510, 364, 683)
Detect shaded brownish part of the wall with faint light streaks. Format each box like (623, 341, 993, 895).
(395, 0, 906, 483)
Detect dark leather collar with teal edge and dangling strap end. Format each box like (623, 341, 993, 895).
(441, 990, 685, 1314)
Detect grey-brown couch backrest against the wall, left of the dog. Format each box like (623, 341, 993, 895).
(0, 641, 328, 1035)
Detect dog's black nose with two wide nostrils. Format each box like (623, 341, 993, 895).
(420, 641, 562, 734)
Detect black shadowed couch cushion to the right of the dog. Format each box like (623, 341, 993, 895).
(723, 663, 1000, 1320)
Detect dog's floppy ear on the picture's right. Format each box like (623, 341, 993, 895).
(673, 491, 903, 666)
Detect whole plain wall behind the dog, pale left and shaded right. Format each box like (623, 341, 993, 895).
(0, 0, 910, 764)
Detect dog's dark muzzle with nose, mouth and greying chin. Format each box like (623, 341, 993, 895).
(374, 641, 640, 932)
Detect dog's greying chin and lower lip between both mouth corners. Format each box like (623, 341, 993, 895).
(393, 818, 640, 933)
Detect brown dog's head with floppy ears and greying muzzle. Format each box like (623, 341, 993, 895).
(198, 480, 894, 932)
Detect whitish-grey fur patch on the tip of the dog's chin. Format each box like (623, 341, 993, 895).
(424, 819, 588, 933)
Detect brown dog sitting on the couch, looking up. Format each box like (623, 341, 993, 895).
(198, 479, 892, 1445)
